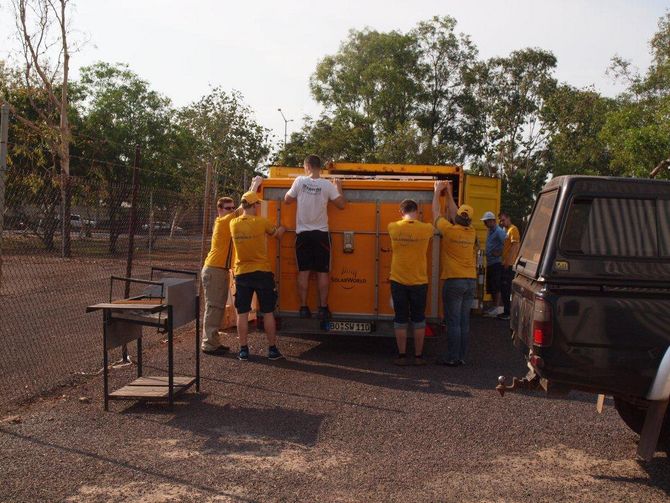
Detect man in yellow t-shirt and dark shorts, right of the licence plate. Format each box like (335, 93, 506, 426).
(388, 199, 435, 365)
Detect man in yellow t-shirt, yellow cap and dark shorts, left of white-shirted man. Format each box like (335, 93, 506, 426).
(230, 187, 285, 361)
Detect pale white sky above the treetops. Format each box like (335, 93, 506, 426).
(0, 0, 670, 150)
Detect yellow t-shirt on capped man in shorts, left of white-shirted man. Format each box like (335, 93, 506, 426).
(230, 215, 277, 275)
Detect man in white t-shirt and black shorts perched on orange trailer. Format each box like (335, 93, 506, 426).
(284, 155, 346, 321)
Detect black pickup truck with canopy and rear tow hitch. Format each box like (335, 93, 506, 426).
(497, 176, 670, 459)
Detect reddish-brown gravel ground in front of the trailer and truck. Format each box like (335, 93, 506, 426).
(0, 319, 670, 502)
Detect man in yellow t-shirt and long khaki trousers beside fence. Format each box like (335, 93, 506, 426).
(200, 176, 263, 356)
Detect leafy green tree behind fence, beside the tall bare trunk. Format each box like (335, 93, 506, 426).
(78, 63, 184, 253)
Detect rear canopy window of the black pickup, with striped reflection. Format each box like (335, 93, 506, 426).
(560, 197, 668, 258)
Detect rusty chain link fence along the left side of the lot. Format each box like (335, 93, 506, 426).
(0, 169, 227, 408)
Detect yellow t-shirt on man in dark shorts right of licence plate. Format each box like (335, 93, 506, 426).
(388, 219, 435, 285)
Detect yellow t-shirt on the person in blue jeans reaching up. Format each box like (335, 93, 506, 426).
(435, 217, 477, 279)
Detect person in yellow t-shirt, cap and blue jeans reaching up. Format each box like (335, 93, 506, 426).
(433, 181, 477, 367)
